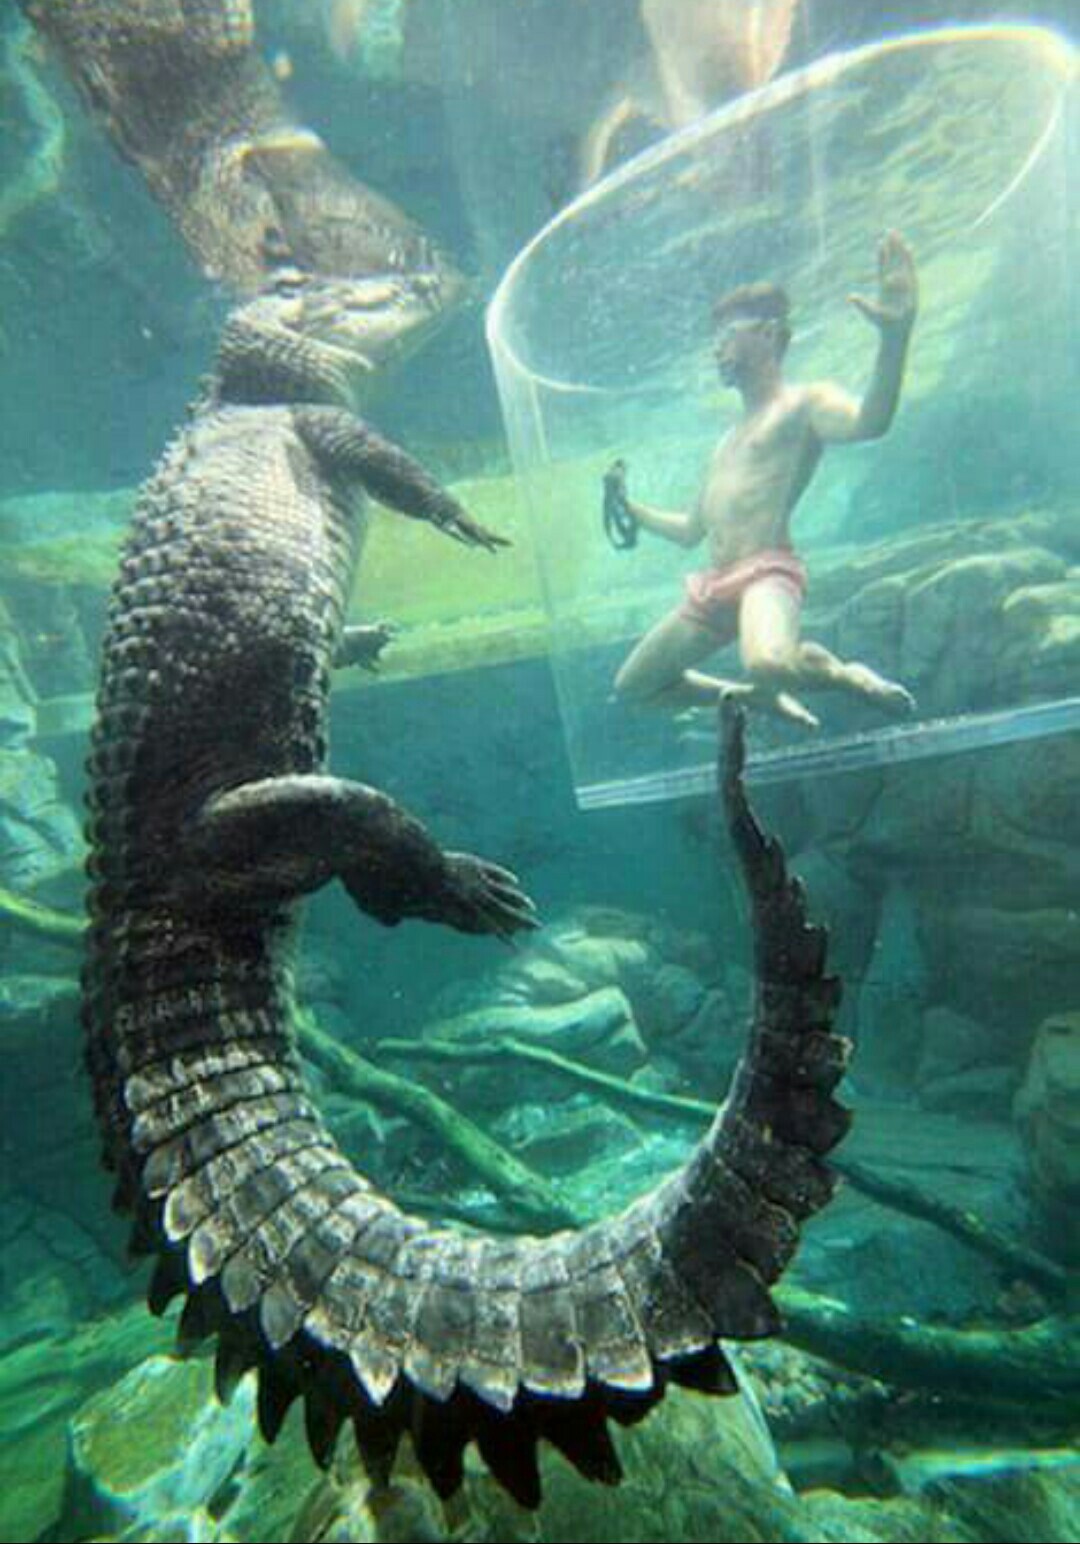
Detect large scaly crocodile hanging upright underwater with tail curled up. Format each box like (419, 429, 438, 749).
(83, 272, 848, 1505)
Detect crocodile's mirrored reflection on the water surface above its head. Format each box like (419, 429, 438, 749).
(20, 0, 467, 372)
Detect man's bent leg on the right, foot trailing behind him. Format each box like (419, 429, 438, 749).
(739, 577, 915, 718)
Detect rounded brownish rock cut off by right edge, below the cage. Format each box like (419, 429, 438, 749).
(1014, 1011, 1080, 1266)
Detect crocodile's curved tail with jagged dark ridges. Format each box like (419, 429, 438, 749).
(118, 709, 848, 1505)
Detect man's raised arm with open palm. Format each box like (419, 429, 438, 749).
(807, 232, 918, 445)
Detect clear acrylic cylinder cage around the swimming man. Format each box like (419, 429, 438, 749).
(488, 26, 1080, 808)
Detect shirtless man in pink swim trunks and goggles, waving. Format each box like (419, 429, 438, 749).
(609, 232, 918, 729)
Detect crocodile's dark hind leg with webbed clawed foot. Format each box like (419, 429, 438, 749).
(170, 775, 536, 937)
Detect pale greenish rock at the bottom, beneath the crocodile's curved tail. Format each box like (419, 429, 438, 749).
(51, 1315, 797, 1544)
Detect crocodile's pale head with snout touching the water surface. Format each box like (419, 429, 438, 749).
(218, 266, 464, 403)
